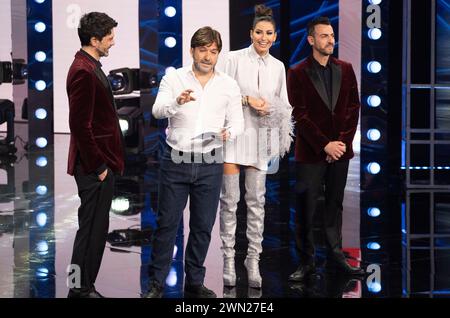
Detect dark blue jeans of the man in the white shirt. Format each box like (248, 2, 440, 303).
(149, 147, 223, 286)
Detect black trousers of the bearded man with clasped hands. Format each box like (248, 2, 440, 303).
(296, 160, 349, 264)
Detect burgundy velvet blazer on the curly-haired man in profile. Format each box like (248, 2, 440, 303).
(66, 52, 124, 175)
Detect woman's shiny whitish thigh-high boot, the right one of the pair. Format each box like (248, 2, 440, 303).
(244, 168, 266, 288)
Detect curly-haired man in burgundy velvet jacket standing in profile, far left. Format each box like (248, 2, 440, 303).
(67, 12, 124, 298)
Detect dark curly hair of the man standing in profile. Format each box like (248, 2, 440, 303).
(78, 12, 118, 46)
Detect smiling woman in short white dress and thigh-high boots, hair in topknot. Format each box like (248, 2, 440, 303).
(220, 5, 292, 288)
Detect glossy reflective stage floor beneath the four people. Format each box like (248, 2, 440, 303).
(0, 135, 450, 298)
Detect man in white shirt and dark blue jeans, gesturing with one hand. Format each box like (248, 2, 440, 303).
(144, 27, 244, 298)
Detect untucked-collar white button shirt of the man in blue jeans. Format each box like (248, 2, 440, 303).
(152, 65, 244, 153)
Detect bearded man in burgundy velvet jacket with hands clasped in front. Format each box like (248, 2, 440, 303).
(288, 17, 364, 281)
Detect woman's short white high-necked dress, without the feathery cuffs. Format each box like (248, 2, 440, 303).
(224, 45, 289, 171)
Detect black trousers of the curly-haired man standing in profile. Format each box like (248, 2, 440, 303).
(71, 164, 114, 290)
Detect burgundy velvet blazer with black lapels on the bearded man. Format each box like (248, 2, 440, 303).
(287, 56, 360, 163)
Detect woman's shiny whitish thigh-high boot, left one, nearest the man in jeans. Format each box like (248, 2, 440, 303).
(220, 173, 240, 286)
